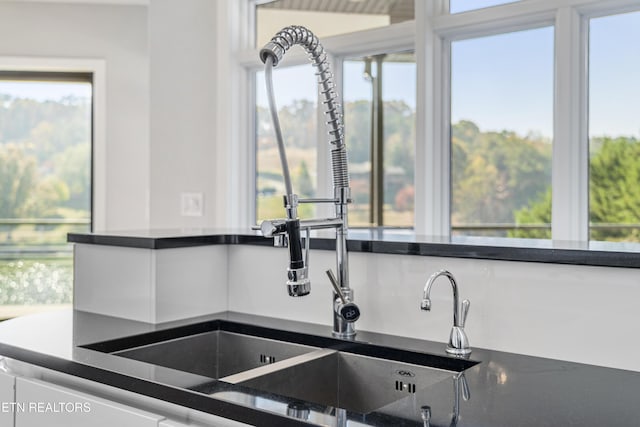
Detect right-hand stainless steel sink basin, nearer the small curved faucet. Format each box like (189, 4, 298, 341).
(222, 349, 456, 414)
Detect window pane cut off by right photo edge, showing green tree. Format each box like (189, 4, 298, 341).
(589, 12, 640, 242)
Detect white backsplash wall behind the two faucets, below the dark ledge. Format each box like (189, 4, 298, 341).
(228, 245, 640, 371)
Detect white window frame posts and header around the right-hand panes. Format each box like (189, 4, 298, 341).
(234, 0, 640, 243)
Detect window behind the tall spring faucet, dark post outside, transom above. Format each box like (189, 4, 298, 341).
(255, 0, 416, 228)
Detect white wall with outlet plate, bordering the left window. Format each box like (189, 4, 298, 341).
(0, 0, 225, 230)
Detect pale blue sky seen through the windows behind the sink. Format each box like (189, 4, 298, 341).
(258, 5, 640, 138)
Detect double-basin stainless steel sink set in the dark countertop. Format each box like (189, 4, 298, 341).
(83, 320, 477, 414)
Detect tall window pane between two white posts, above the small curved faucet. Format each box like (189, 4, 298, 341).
(451, 27, 553, 238)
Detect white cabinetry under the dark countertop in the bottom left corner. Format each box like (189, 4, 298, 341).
(5, 362, 249, 427)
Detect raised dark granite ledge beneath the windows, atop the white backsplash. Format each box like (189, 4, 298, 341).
(68, 229, 640, 268)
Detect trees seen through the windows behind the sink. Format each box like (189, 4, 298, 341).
(258, 100, 640, 241)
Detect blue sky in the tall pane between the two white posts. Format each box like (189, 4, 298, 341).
(451, 27, 553, 137)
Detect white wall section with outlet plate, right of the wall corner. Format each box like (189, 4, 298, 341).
(149, 0, 217, 228)
